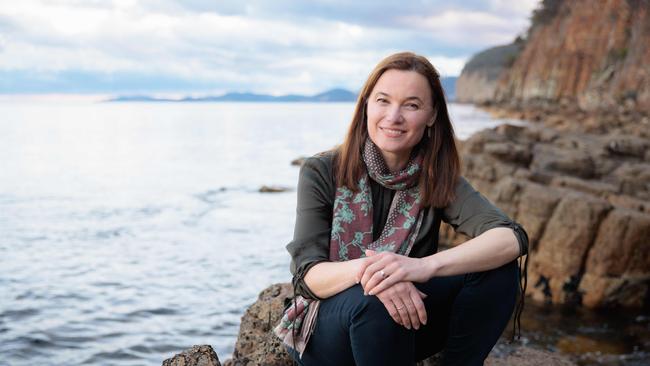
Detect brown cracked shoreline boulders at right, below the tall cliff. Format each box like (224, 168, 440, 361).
(441, 105, 650, 307)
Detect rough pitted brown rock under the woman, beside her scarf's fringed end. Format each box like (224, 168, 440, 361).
(225, 283, 293, 366)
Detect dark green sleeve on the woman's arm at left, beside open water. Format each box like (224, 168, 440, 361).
(287, 157, 334, 299)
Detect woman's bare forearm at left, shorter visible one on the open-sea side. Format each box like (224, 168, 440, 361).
(304, 258, 363, 299)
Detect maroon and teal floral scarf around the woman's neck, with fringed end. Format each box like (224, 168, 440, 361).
(274, 139, 423, 356)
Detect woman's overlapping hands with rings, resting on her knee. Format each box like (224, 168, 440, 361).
(356, 249, 429, 329)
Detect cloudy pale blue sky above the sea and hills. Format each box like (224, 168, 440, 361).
(0, 0, 538, 95)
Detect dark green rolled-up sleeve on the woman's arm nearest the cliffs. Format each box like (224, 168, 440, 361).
(442, 177, 528, 256)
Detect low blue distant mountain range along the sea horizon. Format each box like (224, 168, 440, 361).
(106, 77, 457, 103)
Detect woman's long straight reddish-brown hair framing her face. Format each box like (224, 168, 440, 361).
(334, 52, 460, 207)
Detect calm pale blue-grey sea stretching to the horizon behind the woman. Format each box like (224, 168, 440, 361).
(5, 101, 632, 365)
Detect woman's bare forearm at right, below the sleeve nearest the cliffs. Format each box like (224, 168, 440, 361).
(423, 227, 519, 278)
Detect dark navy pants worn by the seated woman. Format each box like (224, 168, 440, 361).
(289, 261, 519, 366)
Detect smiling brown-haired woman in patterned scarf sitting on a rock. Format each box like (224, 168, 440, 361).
(275, 53, 528, 366)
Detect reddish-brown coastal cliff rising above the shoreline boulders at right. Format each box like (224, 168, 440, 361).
(457, 0, 650, 112)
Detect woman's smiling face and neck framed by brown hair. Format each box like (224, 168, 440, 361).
(367, 69, 433, 172)
